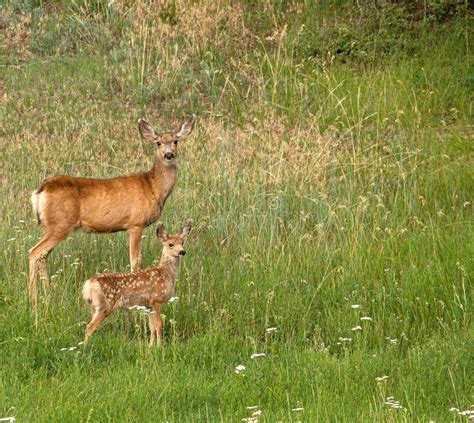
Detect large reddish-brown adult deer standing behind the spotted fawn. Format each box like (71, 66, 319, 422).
(29, 115, 196, 306)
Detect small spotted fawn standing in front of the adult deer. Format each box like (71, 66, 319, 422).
(82, 220, 192, 346)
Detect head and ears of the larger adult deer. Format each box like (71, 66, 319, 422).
(138, 115, 196, 165)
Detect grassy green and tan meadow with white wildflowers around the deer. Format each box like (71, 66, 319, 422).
(0, 0, 474, 422)
